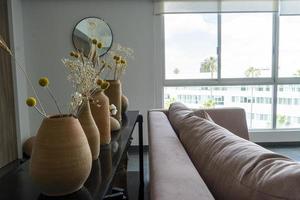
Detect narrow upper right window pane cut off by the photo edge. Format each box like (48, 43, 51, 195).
(278, 16, 300, 77)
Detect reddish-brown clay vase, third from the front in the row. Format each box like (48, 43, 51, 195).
(91, 91, 111, 145)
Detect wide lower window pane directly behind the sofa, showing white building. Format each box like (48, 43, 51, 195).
(164, 85, 273, 129)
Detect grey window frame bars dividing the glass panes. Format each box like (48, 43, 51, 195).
(160, 12, 300, 133)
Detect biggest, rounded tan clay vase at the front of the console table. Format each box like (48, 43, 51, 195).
(30, 115, 92, 196)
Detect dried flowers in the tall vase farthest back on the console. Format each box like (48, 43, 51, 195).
(101, 44, 134, 80)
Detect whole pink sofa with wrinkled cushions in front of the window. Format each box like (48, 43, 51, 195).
(148, 103, 300, 200)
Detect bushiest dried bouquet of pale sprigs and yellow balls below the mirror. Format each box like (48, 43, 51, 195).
(62, 39, 109, 116)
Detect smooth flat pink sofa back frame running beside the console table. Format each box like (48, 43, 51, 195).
(148, 111, 214, 200)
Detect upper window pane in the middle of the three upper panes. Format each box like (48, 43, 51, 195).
(221, 13, 273, 78)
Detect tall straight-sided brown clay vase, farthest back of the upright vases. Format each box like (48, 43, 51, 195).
(105, 80, 122, 122)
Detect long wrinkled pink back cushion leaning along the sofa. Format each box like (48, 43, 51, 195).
(169, 105, 300, 200)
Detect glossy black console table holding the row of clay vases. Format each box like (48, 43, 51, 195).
(0, 111, 144, 200)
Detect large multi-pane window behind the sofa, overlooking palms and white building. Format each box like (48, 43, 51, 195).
(164, 12, 300, 129)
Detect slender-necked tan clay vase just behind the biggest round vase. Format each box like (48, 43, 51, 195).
(78, 101, 100, 160)
